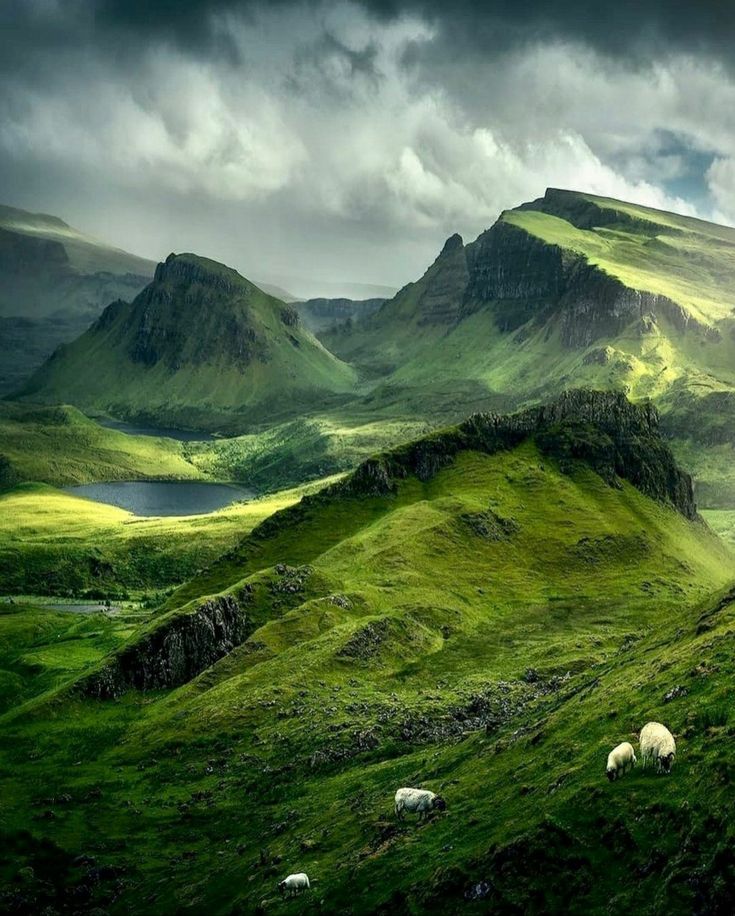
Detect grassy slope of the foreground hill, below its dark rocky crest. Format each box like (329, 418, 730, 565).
(0, 444, 735, 914)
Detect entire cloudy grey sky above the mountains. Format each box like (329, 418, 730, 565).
(0, 0, 735, 294)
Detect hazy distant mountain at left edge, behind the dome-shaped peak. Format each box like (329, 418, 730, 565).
(0, 206, 155, 393)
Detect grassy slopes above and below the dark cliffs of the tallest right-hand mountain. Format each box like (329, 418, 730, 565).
(318, 191, 735, 506)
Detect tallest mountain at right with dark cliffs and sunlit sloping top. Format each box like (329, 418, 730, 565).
(322, 189, 735, 502)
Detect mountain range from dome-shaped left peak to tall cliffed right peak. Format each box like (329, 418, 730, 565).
(14, 189, 735, 505)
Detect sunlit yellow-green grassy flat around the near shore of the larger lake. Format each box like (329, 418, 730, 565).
(0, 484, 330, 596)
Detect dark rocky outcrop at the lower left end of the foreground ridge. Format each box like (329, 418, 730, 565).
(77, 596, 253, 699)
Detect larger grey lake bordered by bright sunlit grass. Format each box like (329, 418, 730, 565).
(63, 480, 256, 516)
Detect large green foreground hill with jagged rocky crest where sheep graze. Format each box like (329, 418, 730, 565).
(0, 391, 735, 916)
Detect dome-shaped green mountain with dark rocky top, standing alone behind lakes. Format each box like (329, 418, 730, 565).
(20, 254, 354, 429)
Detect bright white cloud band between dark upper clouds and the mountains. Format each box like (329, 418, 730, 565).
(0, 2, 735, 281)
